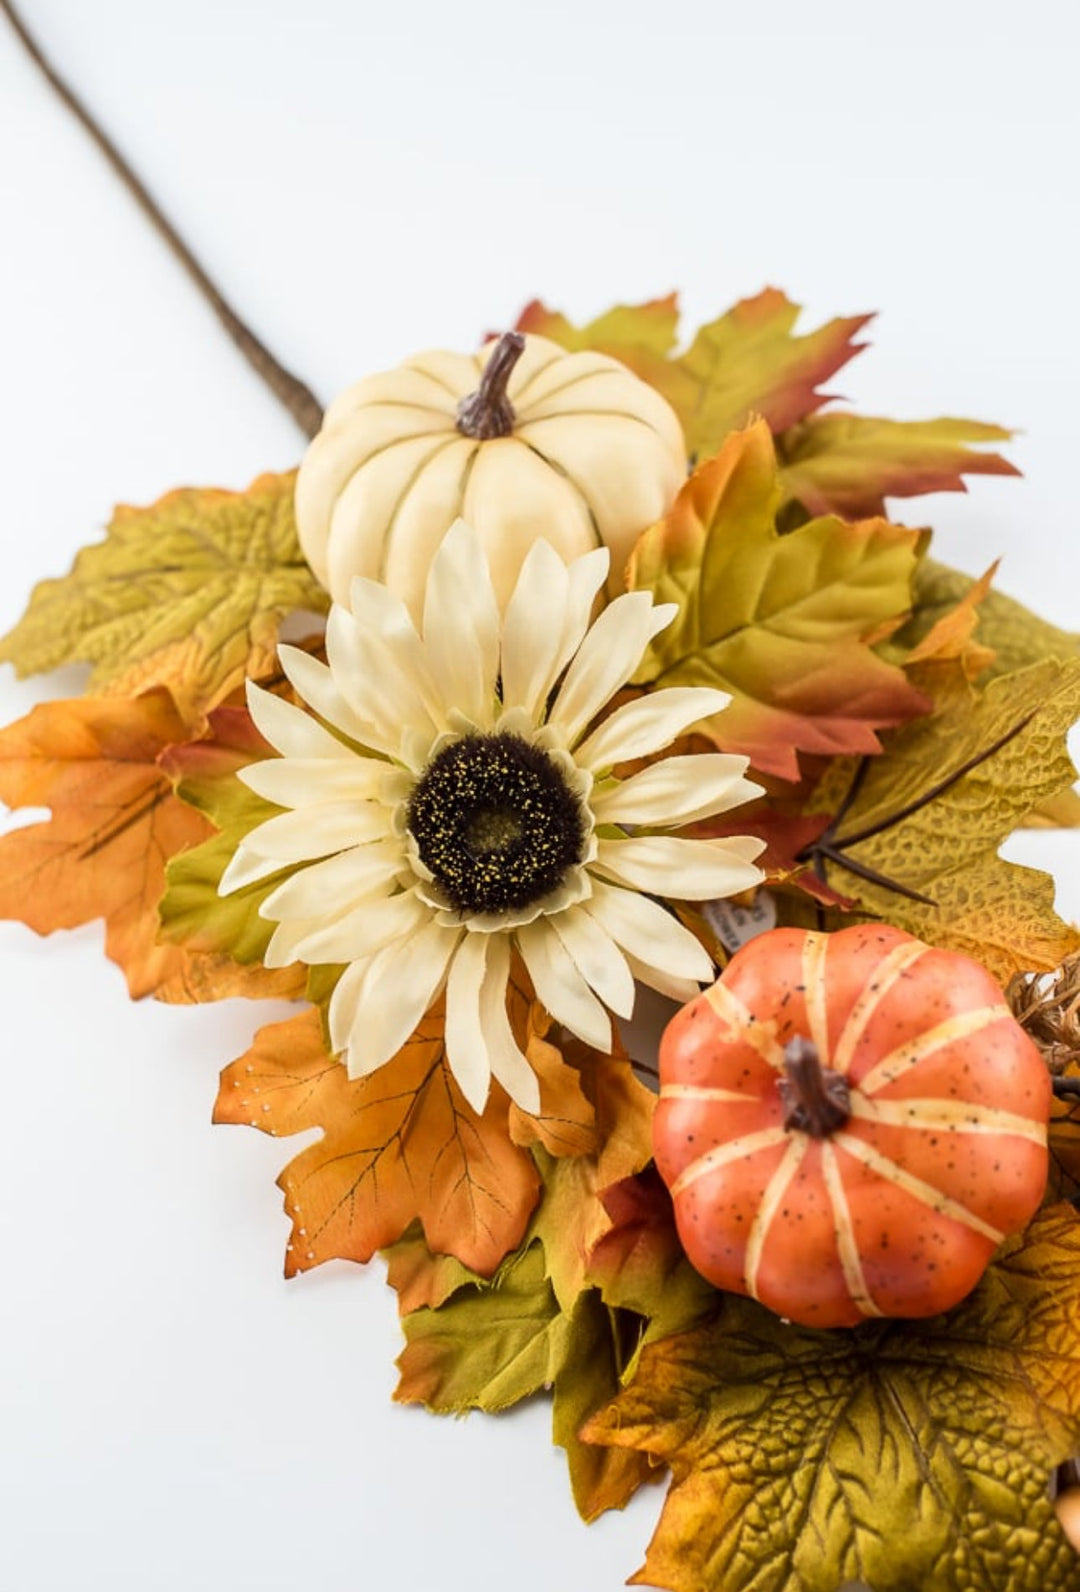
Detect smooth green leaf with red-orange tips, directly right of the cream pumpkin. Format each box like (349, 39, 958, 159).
(628, 422, 930, 780)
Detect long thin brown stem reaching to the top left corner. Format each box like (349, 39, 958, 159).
(0, 0, 322, 436)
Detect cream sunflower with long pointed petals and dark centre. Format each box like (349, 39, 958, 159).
(220, 521, 763, 1111)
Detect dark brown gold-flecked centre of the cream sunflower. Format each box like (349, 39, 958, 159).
(408, 732, 585, 912)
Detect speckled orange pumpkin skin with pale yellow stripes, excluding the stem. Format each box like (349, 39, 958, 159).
(655, 925, 1051, 1326)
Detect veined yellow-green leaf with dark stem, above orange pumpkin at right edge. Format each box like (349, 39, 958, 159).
(809, 659, 1080, 984)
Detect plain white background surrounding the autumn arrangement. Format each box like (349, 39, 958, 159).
(0, 0, 1080, 1592)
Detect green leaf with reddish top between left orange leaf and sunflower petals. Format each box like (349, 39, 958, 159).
(159, 705, 289, 967)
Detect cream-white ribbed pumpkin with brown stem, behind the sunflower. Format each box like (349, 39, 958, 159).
(296, 333, 687, 618)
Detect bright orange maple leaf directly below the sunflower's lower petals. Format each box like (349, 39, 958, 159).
(213, 1006, 540, 1277)
